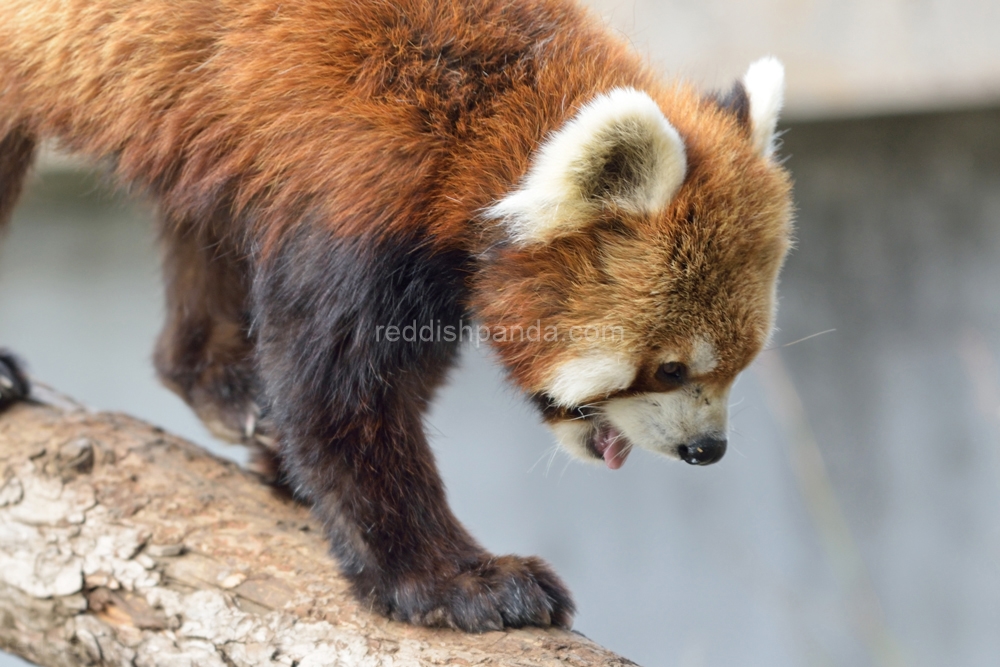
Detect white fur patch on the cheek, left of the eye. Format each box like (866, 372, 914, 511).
(545, 352, 637, 407)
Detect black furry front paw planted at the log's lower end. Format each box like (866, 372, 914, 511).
(390, 556, 575, 632)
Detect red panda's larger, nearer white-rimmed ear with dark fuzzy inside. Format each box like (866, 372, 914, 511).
(485, 88, 687, 244)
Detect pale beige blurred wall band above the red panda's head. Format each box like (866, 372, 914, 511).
(588, 0, 1000, 119)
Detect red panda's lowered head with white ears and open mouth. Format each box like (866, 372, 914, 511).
(476, 59, 792, 468)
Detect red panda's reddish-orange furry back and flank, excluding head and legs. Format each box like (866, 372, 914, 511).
(0, 0, 629, 244)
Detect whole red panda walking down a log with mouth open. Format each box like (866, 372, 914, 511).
(0, 0, 792, 632)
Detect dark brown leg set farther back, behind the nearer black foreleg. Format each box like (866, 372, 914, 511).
(154, 219, 279, 481)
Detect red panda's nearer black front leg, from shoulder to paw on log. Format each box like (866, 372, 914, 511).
(253, 228, 573, 632)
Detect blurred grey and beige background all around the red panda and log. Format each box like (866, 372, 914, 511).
(0, 0, 1000, 667)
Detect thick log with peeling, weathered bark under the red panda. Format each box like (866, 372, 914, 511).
(0, 392, 634, 667)
